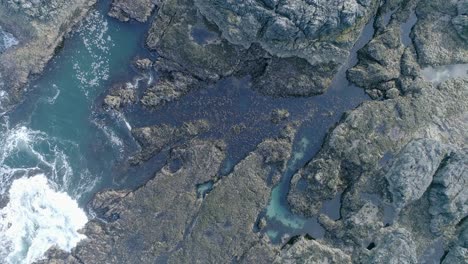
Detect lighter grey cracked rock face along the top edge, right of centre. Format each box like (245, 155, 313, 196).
(195, 0, 373, 65)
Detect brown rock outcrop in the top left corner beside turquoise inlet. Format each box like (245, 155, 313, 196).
(0, 0, 96, 110)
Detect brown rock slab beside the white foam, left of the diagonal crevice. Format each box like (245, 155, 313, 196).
(70, 140, 224, 263)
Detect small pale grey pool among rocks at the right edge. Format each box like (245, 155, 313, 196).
(422, 64, 468, 83)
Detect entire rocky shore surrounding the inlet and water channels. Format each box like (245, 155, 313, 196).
(0, 0, 468, 264)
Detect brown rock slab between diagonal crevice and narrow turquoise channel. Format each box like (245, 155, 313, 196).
(169, 127, 293, 263)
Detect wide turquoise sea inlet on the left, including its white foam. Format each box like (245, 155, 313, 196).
(0, 1, 149, 263)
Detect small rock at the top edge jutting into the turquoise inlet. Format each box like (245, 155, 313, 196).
(109, 0, 161, 22)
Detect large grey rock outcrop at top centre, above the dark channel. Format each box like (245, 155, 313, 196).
(142, 0, 377, 106)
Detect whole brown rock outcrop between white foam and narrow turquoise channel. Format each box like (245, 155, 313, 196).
(42, 127, 294, 263)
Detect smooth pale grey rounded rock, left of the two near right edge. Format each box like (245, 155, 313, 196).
(385, 139, 449, 209)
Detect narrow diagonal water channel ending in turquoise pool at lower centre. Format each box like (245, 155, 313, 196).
(262, 19, 374, 243)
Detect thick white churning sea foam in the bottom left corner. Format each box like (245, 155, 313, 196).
(0, 174, 88, 264)
